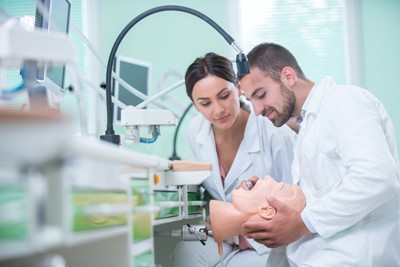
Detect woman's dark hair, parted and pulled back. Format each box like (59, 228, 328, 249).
(185, 52, 238, 101)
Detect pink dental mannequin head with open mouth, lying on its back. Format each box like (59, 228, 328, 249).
(210, 176, 306, 255)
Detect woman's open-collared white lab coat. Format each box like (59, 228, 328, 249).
(188, 112, 296, 253)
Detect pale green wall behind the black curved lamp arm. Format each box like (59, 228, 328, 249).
(98, 0, 231, 159)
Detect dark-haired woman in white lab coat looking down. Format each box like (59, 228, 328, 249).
(173, 53, 295, 267)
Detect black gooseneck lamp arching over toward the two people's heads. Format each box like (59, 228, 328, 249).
(100, 5, 250, 145)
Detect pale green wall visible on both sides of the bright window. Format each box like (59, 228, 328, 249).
(99, 0, 400, 159)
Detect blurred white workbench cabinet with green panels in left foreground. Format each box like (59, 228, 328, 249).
(0, 138, 206, 267)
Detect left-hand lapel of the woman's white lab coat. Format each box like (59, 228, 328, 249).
(195, 122, 227, 201)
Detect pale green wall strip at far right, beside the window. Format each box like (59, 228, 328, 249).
(360, 0, 400, 155)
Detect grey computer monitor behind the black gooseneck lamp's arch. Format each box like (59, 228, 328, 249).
(114, 56, 151, 123)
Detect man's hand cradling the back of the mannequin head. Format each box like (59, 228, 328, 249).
(242, 197, 310, 248)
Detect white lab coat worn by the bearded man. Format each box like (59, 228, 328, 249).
(287, 77, 400, 267)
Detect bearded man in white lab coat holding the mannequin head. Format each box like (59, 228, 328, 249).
(240, 43, 400, 267)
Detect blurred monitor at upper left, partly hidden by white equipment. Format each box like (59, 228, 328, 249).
(35, 0, 71, 95)
